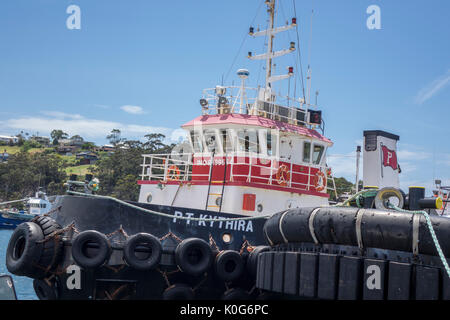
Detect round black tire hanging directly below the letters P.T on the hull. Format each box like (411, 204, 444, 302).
(175, 238, 213, 276)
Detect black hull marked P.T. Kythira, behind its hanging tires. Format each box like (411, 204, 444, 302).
(49, 196, 266, 299)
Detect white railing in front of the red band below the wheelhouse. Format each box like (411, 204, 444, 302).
(141, 153, 333, 192)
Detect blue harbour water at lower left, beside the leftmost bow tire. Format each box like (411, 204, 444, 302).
(0, 230, 37, 300)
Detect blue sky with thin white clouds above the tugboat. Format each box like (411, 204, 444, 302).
(0, 0, 450, 192)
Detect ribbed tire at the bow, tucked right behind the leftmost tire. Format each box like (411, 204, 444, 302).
(32, 216, 63, 279)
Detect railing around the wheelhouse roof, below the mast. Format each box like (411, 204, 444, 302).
(200, 86, 322, 126)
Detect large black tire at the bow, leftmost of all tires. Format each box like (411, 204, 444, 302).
(6, 222, 44, 278)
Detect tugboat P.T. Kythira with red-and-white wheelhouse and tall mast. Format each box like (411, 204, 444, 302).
(7, 0, 333, 299)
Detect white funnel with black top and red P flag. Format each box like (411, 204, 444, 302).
(363, 130, 401, 189)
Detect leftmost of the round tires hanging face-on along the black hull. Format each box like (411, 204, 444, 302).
(72, 230, 111, 269)
